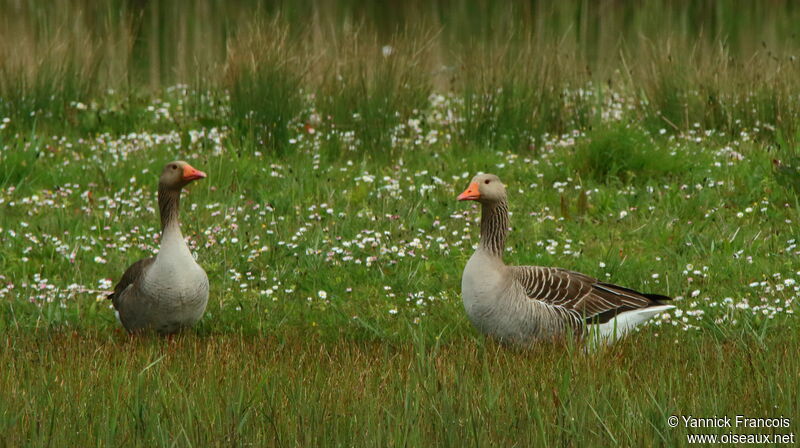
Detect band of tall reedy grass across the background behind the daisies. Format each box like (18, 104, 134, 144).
(0, 0, 800, 144)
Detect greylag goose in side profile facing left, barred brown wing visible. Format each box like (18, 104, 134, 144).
(458, 174, 674, 345)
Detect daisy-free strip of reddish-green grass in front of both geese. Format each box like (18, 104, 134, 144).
(0, 331, 800, 446)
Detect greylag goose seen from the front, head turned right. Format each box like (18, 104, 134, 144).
(108, 161, 208, 334)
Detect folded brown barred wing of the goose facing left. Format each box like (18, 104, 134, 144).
(511, 266, 671, 323)
